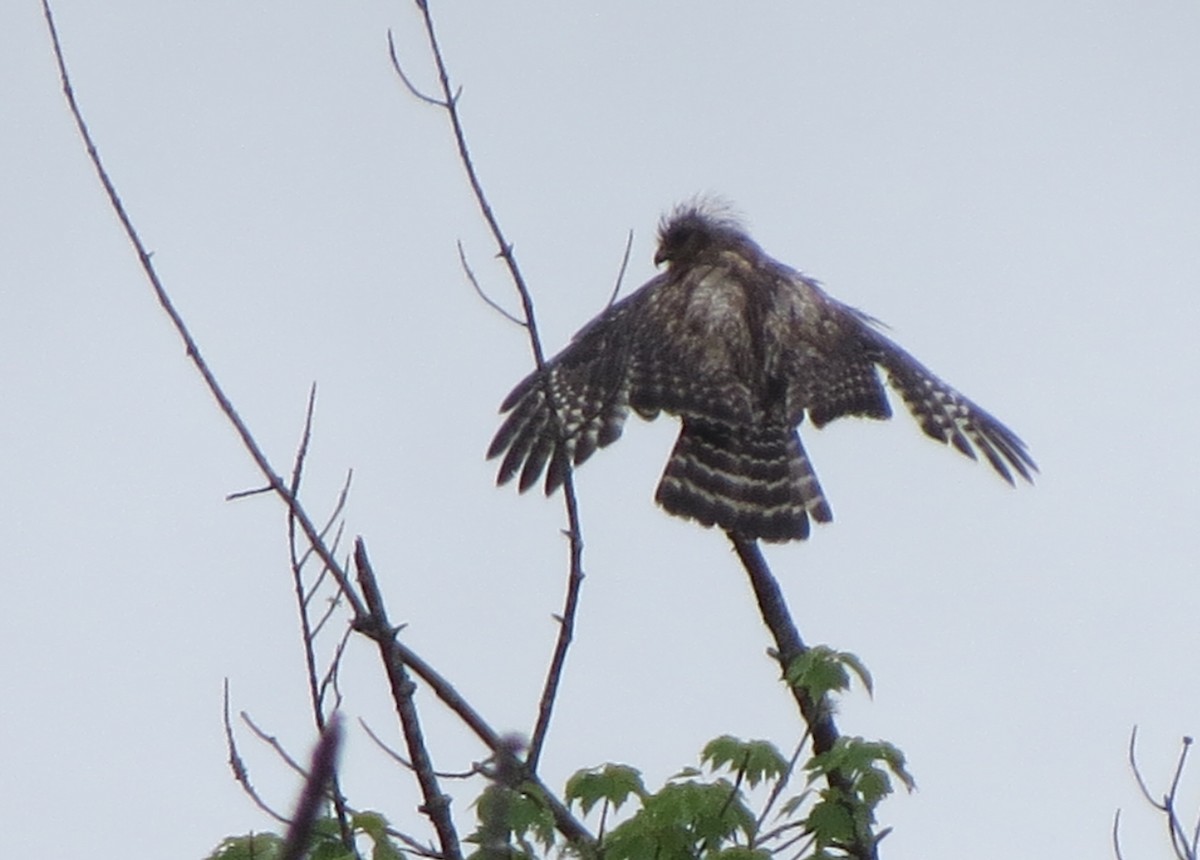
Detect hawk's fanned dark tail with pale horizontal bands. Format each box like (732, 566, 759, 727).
(654, 421, 833, 542)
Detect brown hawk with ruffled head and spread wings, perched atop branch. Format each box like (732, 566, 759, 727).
(487, 202, 1037, 542)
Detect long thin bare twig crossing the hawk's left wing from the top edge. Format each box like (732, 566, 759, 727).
(398, 0, 583, 774)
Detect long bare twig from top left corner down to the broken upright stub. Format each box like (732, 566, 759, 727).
(42, 0, 364, 615)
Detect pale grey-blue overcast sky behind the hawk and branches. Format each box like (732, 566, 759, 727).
(0, 0, 1200, 860)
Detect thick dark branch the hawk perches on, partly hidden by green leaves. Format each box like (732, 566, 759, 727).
(727, 531, 878, 860)
